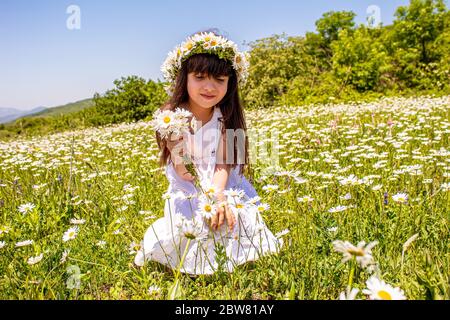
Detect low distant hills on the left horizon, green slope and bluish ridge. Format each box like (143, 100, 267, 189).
(0, 99, 94, 123)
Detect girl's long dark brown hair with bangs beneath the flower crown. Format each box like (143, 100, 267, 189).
(156, 31, 250, 175)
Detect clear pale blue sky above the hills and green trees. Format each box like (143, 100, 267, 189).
(0, 0, 409, 110)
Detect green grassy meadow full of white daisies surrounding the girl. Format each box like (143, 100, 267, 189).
(0, 96, 450, 299)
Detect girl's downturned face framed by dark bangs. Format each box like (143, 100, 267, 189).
(187, 72, 229, 109)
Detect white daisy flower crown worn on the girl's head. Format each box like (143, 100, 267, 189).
(161, 32, 249, 94)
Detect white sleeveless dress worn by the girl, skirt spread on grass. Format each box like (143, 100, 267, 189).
(134, 107, 283, 275)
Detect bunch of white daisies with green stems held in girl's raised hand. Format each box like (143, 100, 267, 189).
(150, 108, 203, 191)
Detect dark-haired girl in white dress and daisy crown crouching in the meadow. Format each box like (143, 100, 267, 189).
(135, 32, 282, 275)
